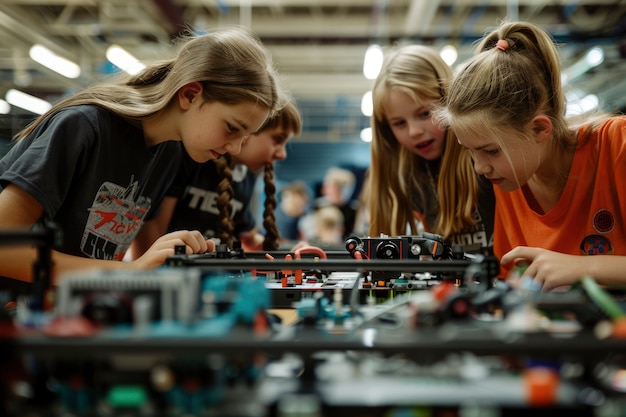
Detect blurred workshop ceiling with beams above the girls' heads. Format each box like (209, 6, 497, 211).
(0, 0, 626, 140)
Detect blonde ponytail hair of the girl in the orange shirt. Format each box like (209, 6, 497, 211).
(435, 22, 592, 182)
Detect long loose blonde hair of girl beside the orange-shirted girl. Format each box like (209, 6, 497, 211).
(368, 45, 478, 237)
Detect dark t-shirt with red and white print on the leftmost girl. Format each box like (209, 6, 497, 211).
(0, 105, 182, 260)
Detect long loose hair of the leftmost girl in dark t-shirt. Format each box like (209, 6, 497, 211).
(16, 26, 284, 139)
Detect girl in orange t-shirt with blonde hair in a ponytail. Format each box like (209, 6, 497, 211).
(437, 22, 626, 290)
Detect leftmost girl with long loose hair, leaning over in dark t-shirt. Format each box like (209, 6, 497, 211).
(0, 28, 282, 284)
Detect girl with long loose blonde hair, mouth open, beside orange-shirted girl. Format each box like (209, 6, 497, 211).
(367, 45, 495, 251)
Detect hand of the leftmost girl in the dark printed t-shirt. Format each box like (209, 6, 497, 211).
(132, 230, 215, 269)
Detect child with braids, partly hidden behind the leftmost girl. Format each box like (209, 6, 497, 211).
(133, 102, 302, 256)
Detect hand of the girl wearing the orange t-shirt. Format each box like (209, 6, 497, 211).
(500, 246, 590, 291)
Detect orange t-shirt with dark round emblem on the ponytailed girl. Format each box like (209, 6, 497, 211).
(494, 117, 626, 277)
